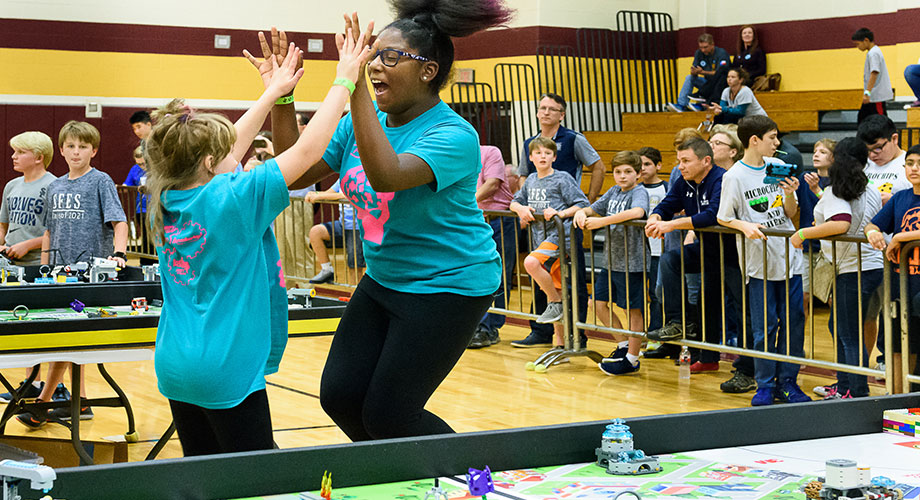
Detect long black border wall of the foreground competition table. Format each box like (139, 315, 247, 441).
(23, 393, 920, 500)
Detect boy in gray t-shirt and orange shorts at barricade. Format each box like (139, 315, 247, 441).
(508, 136, 588, 347)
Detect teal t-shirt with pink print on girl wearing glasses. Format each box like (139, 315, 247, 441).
(323, 102, 501, 297)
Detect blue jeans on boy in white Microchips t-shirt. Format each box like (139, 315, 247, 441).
(748, 275, 805, 389)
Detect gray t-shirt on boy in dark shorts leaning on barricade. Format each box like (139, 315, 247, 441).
(591, 185, 651, 273)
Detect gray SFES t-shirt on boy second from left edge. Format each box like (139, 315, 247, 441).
(45, 168, 125, 264)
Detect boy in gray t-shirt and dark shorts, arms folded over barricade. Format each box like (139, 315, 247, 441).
(575, 151, 651, 375)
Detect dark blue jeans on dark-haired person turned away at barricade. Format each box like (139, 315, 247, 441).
(827, 269, 882, 397)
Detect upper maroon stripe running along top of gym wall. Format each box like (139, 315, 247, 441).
(0, 9, 920, 60)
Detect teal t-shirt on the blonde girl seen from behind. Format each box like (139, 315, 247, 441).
(155, 160, 289, 409)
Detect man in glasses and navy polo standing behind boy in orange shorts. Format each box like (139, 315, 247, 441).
(511, 93, 605, 347)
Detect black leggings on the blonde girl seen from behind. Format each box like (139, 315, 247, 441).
(169, 389, 275, 457)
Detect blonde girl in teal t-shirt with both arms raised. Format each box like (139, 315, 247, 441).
(147, 34, 370, 456)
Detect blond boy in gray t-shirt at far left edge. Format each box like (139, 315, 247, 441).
(0, 132, 54, 266)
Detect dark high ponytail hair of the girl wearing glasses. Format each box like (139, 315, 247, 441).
(384, 0, 514, 93)
